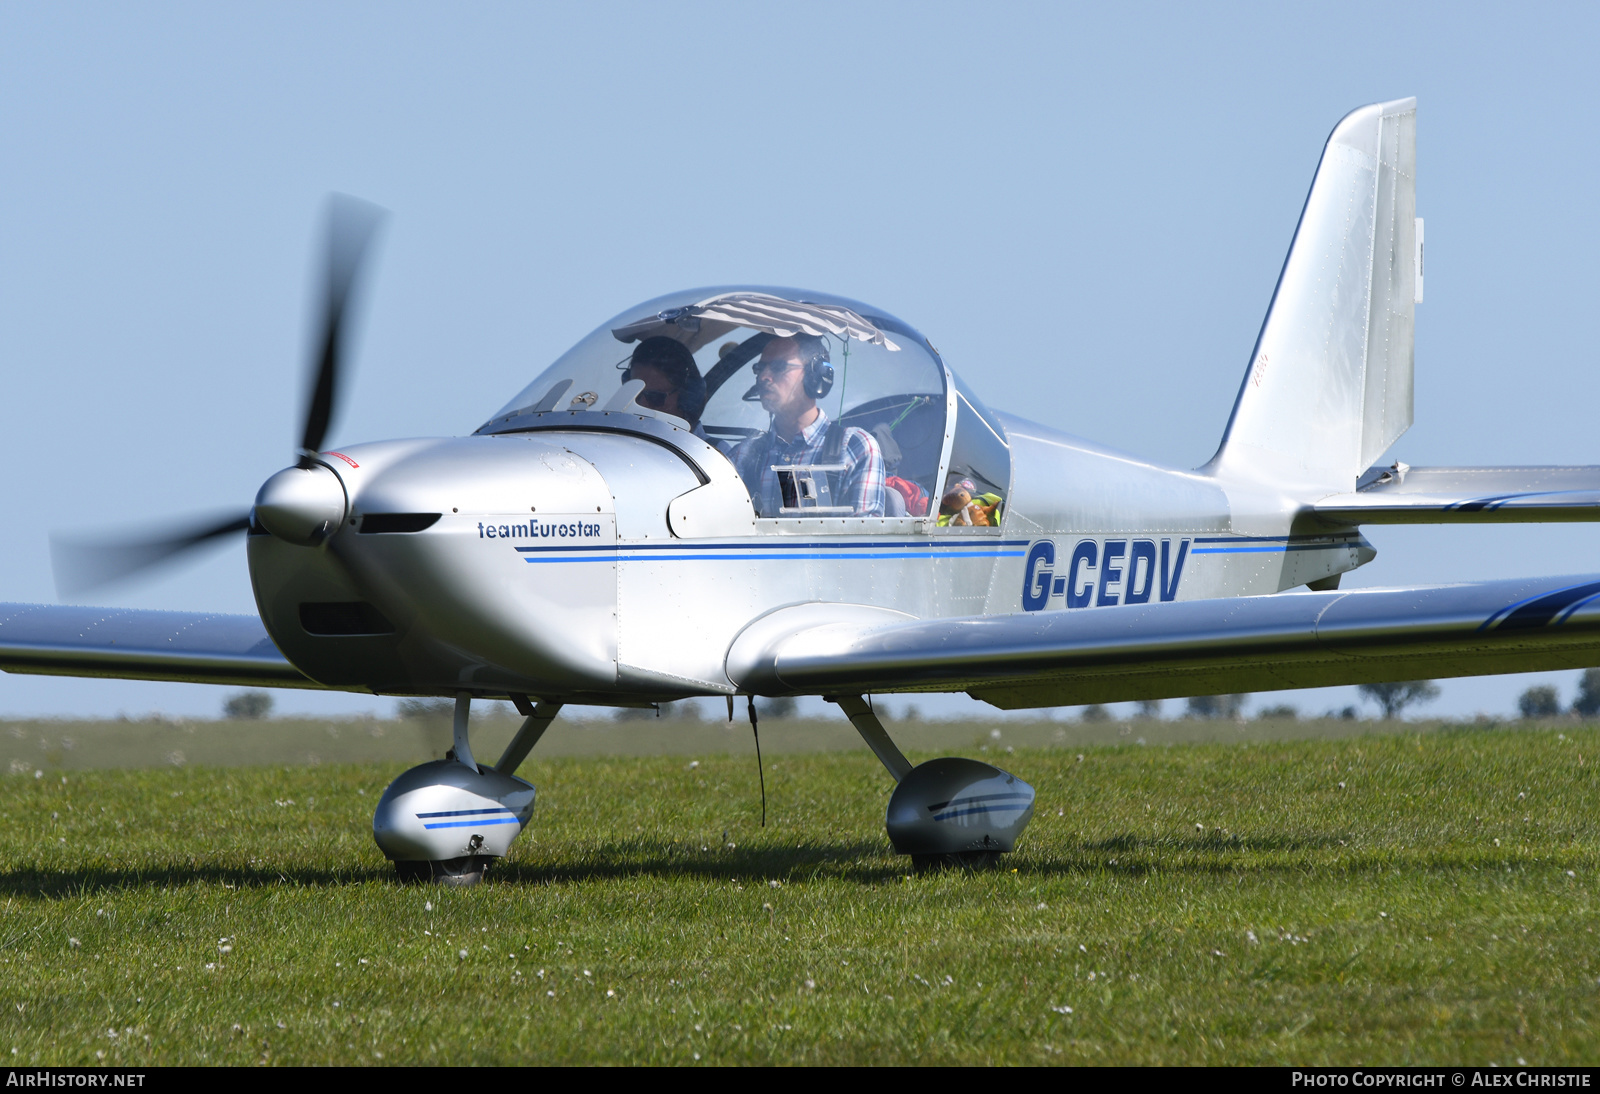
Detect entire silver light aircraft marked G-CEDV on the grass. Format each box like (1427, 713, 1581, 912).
(0, 99, 1600, 883)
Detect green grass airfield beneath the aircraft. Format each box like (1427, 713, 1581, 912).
(0, 723, 1600, 1065)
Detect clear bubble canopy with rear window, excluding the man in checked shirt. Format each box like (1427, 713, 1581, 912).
(485, 286, 1010, 517)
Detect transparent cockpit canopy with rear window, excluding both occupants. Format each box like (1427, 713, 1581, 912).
(478, 286, 1011, 528)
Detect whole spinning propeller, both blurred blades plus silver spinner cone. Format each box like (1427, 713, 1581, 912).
(50, 194, 384, 597)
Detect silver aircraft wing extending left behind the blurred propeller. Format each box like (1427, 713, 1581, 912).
(0, 603, 322, 688)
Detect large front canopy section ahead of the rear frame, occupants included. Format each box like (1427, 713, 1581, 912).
(496, 288, 947, 518)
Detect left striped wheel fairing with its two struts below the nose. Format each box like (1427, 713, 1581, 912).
(373, 693, 562, 884)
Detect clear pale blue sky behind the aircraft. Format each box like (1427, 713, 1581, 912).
(0, 3, 1600, 715)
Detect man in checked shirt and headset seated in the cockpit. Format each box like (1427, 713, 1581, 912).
(728, 334, 885, 517)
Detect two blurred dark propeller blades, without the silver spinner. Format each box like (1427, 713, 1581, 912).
(50, 194, 384, 597)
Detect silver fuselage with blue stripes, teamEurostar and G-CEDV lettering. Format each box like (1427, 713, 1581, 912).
(250, 411, 1374, 704)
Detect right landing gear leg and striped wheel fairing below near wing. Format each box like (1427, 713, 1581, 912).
(827, 696, 1034, 870)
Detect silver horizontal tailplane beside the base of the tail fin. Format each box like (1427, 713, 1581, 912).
(1312, 464, 1600, 525)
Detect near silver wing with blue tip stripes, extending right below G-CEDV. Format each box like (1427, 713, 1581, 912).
(760, 574, 1600, 709)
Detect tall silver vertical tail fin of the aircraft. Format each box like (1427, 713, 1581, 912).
(1206, 99, 1419, 491)
